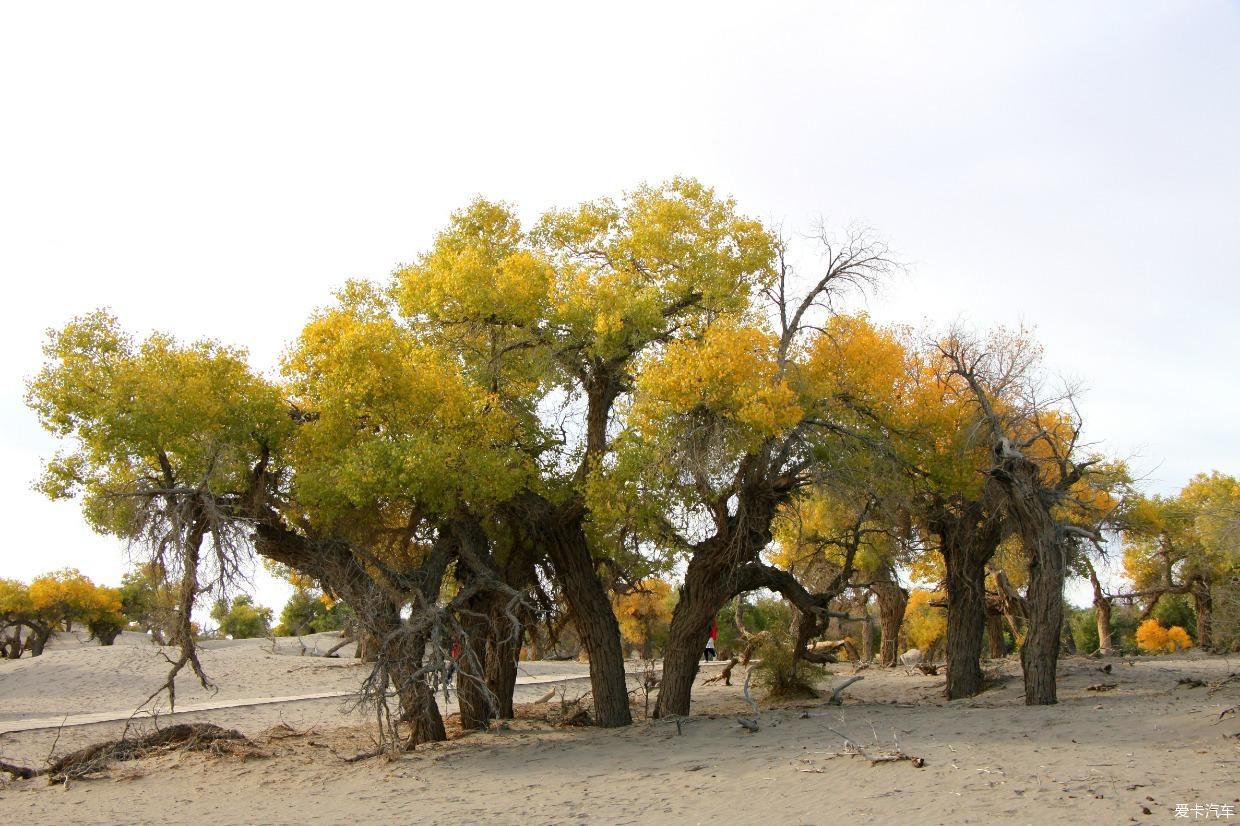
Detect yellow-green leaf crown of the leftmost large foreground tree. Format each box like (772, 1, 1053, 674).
(26, 311, 291, 538)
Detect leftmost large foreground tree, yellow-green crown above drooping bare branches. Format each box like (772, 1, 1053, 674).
(26, 311, 291, 703)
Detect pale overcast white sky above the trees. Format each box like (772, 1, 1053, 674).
(0, 0, 1240, 611)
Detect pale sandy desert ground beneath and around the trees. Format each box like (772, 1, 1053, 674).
(0, 627, 1240, 825)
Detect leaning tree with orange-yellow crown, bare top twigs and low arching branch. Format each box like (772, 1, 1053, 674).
(587, 233, 892, 716)
